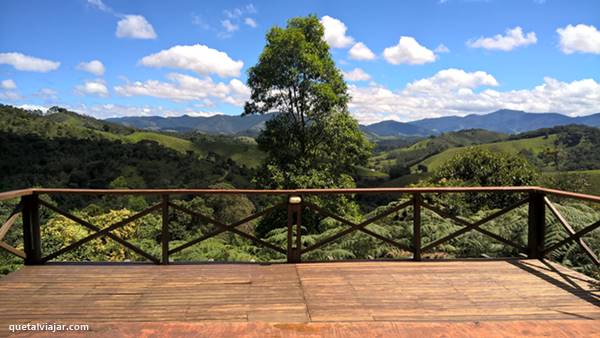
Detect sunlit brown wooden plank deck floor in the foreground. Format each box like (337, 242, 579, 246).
(0, 260, 600, 336)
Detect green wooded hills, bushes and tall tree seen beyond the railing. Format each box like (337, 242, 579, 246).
(0, 16, 600, 277)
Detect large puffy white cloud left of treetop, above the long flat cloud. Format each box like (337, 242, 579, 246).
(140, 45, 244, 77)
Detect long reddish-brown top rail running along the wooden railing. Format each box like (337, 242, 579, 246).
(0, 186, 600, 202)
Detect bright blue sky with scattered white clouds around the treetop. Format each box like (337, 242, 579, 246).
(0, 0, 600, 123)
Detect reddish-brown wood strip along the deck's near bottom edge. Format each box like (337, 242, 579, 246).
(18, 320, 600, 338)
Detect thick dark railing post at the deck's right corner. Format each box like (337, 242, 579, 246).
(527, 191, 546, 258)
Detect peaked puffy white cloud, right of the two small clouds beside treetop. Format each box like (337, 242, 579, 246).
(383, 36, 436, 65)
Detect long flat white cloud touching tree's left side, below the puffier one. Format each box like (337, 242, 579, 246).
(114, 73, 250, 106)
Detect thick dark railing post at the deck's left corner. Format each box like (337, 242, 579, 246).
(21, 194, 42, 265)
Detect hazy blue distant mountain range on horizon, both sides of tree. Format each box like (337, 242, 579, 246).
(107, 109, 600, 137)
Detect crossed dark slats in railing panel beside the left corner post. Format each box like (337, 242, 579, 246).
(40, 200, 162, 264)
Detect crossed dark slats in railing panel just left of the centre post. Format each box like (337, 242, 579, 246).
(169, 203, 287, 255)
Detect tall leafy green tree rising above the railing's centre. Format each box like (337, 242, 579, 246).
(244, 15, 371, 188)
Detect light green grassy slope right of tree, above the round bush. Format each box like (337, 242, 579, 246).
(414, 135, 556, 171)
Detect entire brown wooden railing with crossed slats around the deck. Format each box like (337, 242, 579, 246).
(0, 187, 600, 266)
